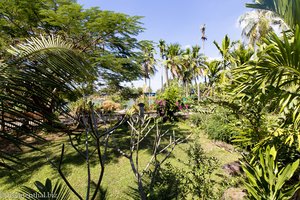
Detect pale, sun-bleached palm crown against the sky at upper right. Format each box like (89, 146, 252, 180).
(239, 10, 287, 47)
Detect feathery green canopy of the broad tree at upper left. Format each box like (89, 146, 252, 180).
(0, 0, 143, 90)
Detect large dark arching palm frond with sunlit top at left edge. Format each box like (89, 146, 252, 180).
(0, 36, 94, 167)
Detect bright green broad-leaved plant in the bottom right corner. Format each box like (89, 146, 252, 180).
(242, 146, 300, 200)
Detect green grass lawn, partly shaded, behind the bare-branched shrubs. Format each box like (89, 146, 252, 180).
(0, 121, 239, 200)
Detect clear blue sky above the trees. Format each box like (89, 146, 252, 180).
(78, 0, 252, 91)
